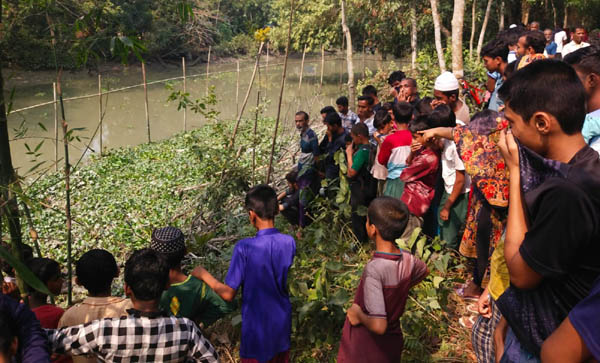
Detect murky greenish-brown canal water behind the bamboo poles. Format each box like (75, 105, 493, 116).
(4, 55, 400, 175)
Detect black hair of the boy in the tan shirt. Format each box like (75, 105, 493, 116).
(75, 249, 119, 295)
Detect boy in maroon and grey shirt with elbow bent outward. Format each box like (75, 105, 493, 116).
(337, 197, 429, 363)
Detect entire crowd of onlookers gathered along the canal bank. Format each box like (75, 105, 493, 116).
(0, 22, 600, 363)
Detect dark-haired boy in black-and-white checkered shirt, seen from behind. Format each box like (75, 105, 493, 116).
(47, 248, 217, 363)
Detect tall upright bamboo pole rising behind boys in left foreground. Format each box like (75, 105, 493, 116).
(56, 69, 72, 305)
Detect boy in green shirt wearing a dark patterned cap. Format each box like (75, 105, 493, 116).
(150, 227, 233, 327)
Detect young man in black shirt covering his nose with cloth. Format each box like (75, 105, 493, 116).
(497, 60, 600, 361)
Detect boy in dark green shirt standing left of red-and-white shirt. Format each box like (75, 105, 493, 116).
(346, 123, 376, 243)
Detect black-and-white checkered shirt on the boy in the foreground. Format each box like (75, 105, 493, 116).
(46, 309, 218, 363)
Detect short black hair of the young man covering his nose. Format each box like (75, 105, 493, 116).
(498, 60, 586, 135)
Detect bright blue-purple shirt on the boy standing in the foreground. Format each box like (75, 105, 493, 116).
(225, 228, 296, 362)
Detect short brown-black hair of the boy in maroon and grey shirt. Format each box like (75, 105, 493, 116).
(367, 197, 410, 243)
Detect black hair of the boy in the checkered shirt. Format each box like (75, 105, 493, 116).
(125, 248, 169, 301)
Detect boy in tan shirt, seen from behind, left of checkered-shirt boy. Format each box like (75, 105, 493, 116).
(58, 249, 132, 363)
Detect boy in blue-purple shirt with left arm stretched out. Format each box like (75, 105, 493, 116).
(192, 185, 296, 362)
